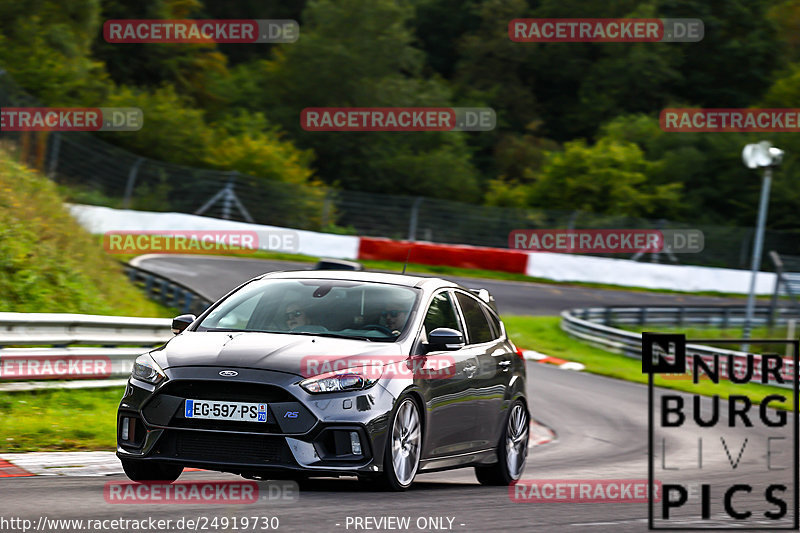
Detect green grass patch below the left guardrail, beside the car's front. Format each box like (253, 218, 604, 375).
(0, 387, 125, 453)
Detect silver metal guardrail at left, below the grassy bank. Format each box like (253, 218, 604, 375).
(0, 313, 172, 381)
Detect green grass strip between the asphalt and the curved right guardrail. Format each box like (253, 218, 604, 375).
(503, 316, 794, 409)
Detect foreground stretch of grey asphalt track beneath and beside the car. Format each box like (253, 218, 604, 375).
(0, 363, 791, 532)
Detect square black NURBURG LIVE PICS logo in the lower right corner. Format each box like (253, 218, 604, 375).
(642, 333, 800, 531)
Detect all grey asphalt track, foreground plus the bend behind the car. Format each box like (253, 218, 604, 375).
(0, 257, 794, 532)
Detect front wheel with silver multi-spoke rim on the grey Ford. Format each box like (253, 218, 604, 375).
(378, 396, 422, 492)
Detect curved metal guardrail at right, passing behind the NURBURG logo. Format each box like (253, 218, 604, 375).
(561, 306, 798, 387)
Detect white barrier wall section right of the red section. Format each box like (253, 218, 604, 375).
(526, 252, 776, 294)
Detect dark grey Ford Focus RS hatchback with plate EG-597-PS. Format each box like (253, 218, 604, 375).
(117, 271, 529, 490)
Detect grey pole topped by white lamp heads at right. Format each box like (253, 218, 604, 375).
(742, 141, 783, 352)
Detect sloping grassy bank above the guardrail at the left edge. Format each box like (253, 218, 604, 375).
(0, 148, 167, 316)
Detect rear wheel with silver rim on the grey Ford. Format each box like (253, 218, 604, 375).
(475, 400, 530, 486)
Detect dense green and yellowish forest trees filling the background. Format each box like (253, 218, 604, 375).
(0, 0, 800, 228)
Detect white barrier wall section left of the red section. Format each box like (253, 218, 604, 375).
(69, 205, 359, 259)
